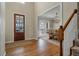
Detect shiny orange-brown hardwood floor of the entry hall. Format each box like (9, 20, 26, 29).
(6, 39, 59, 56)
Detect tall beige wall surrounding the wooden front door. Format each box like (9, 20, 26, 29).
(5, 2, 34, 42)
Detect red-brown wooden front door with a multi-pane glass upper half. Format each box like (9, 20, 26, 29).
(14, 14, 25, 41)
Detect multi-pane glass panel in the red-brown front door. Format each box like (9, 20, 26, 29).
(16, 15, 24, 32)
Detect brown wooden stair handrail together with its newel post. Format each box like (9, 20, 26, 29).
(57, 9, 77, 56)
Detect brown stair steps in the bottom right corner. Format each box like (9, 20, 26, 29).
(70, 39, 79, 56)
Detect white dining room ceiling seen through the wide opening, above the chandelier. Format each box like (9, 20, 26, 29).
(39, 6, 60, 19)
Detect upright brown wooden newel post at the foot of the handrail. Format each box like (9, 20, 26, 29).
(58, 26, 64, 56)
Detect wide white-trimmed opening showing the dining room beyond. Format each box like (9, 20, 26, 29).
(38, 3, 63, 41)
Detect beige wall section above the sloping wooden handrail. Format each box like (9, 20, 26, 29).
(63, 2, 77, 24)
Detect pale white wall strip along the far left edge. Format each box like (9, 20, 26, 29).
(0, 2, 5, 56)
